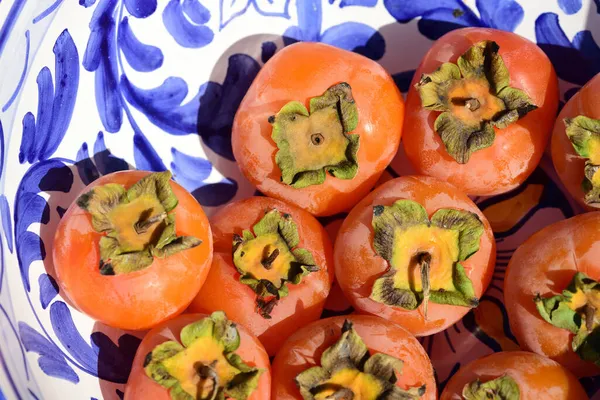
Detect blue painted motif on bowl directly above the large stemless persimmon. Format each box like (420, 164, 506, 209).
(283, 0, 385, 60)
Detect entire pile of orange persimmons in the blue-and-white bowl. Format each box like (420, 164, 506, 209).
(53, 28, 600, 400)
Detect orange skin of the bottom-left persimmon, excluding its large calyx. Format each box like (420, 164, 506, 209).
(125, 314, 271, 400)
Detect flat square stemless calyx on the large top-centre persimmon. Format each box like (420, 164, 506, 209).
(269, 82, 360, 189)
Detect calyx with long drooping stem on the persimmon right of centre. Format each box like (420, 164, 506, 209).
(370, 200, 483, 317)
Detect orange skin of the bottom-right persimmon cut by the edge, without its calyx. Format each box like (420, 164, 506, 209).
(440, 351, 588, 400)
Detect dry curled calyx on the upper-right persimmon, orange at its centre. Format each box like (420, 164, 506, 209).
(415, 40, 537, 164)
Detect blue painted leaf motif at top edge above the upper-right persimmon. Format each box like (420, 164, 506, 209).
(383, 0, 524, 40)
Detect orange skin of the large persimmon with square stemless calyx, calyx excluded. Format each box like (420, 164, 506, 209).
(232, 42, 404, 216)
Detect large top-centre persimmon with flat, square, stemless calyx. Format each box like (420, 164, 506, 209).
(232, 42, 404, 216)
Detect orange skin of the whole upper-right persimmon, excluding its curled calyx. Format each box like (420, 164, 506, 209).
(402, 28, 559, 196)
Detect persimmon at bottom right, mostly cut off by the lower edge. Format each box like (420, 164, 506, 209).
(440, 351, 588, 400)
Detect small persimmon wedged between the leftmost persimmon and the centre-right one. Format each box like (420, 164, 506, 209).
(189, 197, 333, 355)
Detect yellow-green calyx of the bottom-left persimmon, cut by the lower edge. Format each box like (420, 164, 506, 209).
(144, 311, 263, 400)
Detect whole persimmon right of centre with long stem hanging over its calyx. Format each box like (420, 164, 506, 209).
(334, 176, 496, 336)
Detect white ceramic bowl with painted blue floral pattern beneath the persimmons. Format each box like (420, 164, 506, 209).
(0, 0, 600, 400)
